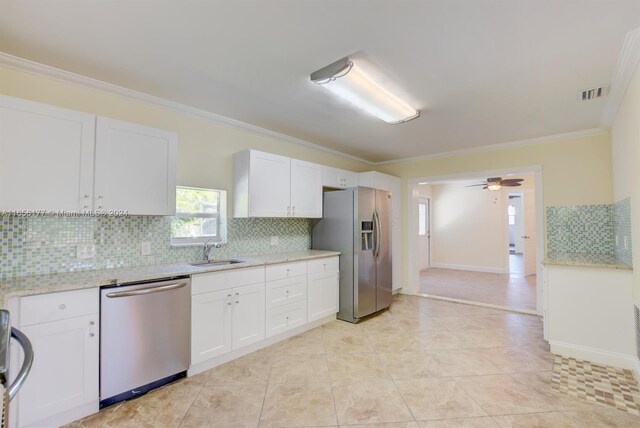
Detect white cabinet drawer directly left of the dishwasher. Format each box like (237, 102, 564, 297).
(20, 288, 99, 326)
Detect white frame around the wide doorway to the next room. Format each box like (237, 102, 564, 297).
(408, 165, 546, 316)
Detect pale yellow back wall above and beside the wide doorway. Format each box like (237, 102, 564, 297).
(377, 133, 613, 285)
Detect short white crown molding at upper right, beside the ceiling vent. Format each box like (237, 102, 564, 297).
(600, 28, 640, 128)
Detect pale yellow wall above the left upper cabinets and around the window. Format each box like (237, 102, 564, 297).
(0, 67, 372, 217)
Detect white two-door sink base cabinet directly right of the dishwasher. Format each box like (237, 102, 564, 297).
(191, 267, 265, 365)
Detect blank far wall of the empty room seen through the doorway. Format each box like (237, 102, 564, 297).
(431, 180, 509, 273)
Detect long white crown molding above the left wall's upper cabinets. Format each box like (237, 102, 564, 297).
(0, 52, 376, 165)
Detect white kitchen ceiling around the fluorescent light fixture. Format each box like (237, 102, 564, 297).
(0, 0, 640, 161)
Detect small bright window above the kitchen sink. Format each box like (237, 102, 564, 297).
(171, 186, 227, 245)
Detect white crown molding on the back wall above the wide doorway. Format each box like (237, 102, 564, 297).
(375, 128, 609, 165)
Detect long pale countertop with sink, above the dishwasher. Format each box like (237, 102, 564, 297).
(0, 250, 340, 307)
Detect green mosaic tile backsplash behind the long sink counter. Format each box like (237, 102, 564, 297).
(0, 216, 311, 279)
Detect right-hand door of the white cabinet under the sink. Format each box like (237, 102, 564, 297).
(233, 283, 264, 349)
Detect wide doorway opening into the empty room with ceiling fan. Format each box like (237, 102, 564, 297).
(405, 167, 544, 314)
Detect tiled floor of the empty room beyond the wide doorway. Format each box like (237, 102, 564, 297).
(420, 254, 536, 311)
